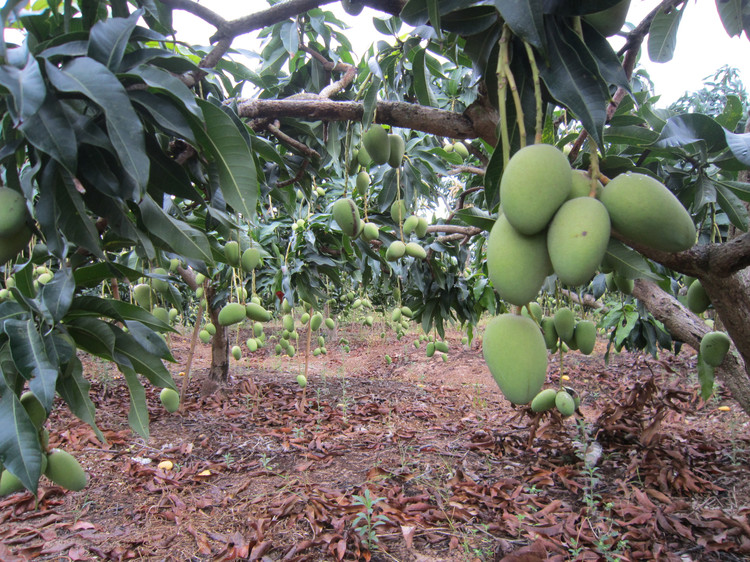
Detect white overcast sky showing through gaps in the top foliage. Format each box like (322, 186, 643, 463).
(174, 0, 750, 107)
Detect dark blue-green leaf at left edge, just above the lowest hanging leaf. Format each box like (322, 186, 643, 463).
(3, 319, 57, 412)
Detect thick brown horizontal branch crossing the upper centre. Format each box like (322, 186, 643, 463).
(237, 98, 490, 142)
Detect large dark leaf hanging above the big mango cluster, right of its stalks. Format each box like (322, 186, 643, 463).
(539, 25, 609, 146)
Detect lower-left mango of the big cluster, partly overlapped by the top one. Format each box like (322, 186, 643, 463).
(487, 215, 550, 306)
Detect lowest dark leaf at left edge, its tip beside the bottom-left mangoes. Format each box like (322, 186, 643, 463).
(0, 376, 42, 493)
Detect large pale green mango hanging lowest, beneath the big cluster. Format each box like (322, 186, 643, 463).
(482, 314, 547, 404)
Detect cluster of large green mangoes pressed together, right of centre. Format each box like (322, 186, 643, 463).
(487, 144, 696, 306)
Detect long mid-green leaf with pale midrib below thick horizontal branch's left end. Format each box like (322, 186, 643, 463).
(193, 100, 258, 221)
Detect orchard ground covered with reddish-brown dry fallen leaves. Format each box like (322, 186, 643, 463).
(0, 320, 750, 562)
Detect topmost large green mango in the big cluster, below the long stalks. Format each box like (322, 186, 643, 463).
(500, 144, 573, 236)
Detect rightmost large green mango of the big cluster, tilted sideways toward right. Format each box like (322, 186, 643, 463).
(601, 172, 695, 252)
